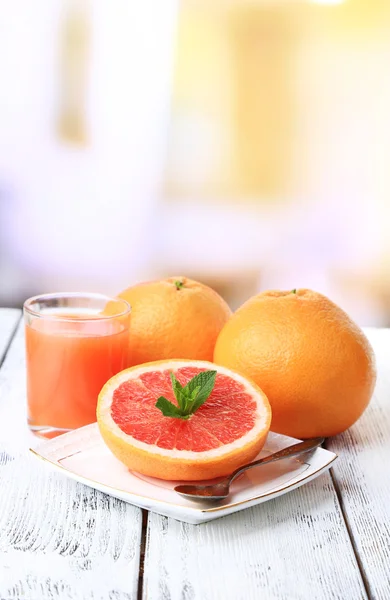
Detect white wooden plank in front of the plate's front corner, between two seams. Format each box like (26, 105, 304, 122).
(143, 473, 367, 600)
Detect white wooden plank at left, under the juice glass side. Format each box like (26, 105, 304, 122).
(0, 316, 142, 600)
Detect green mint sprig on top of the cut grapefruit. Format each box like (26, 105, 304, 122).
(156, 371, 217, 419)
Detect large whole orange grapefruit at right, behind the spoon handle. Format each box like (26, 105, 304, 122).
(214, 289, 376, 438)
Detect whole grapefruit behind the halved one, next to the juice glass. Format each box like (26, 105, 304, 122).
(119, 277, 231, 366)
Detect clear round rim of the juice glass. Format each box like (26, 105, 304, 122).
(23, 292, 131, 323)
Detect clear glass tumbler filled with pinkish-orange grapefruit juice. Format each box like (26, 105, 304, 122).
(23, 293, 131, 437)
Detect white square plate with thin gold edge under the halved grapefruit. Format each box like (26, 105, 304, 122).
(30, 423, 337, 524)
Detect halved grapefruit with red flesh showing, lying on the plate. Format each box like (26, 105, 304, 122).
(97, 360, 271, 481)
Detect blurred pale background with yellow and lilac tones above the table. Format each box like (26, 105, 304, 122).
(0, 0, 390, 326)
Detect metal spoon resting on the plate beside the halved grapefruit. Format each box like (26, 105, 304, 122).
(174, 438, 324, 500)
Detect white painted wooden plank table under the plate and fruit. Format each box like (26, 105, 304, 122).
(0, 309, 390, 600)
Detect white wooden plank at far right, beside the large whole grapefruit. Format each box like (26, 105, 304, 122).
(328, 329, 390, 600)
